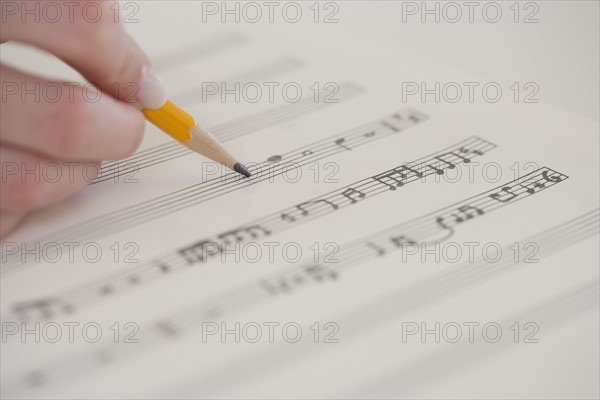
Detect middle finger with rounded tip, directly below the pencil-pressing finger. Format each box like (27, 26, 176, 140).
(0, 65, 145, 161)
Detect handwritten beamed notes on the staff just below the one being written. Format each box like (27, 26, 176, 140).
(9, 137, 495, 320)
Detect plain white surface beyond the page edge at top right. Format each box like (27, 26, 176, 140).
(339, 0, 600, 121)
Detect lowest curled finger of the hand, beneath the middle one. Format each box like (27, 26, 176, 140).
(0, 144, 100, 214)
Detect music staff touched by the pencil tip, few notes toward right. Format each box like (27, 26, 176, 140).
(2, 109, 426, 274)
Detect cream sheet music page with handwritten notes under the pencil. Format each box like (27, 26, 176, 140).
(0, 2, 600, 398)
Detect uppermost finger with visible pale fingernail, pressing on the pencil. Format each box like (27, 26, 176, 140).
(0, 1, 167, 108)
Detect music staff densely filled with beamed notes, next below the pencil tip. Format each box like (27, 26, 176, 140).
(7, 137, 495, 320)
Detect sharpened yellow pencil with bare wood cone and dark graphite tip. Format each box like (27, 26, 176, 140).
(142, 100, 250, 177)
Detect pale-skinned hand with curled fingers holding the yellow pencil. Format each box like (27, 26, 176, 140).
(0, 1, 166, 238)
